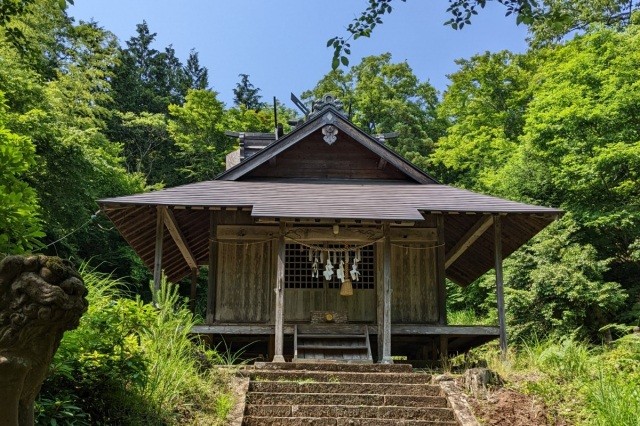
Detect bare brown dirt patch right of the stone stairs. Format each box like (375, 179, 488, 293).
(470, 388, 566, 426)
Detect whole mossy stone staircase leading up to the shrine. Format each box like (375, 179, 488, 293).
(242, 363, 458, 426)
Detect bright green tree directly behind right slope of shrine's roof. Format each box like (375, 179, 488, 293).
(432, 51, 533, 187)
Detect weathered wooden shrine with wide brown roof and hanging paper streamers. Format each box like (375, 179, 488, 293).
(99, 96, 561, 363)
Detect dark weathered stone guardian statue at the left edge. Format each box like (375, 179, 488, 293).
(0, 256, 88, 426)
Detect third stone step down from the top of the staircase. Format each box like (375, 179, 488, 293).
(249, 381, 440, 396)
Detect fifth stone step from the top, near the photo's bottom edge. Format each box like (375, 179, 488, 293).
(245, 404, 455, 422)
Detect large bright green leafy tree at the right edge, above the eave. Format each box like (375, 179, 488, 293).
(498, 25, 640, 287)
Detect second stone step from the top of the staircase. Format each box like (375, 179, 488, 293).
(248, 370, 431, 384)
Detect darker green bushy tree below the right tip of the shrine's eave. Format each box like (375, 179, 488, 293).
(506, 217, 628, 340)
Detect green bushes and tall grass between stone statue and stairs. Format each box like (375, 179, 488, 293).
(38, 268, 229, 424)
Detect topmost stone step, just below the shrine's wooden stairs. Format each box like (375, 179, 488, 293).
(252, 362, 413, 373)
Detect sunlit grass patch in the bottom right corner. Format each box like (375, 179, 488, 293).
(485, 334, 640, 426)
